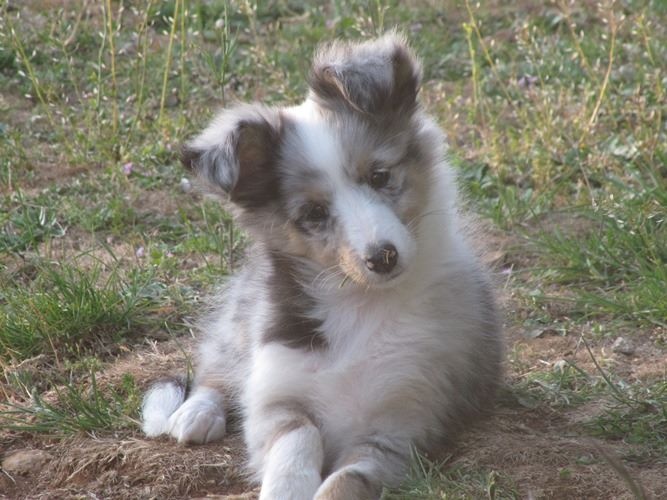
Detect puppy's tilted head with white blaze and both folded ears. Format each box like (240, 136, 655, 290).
(183, 33, 442, 286)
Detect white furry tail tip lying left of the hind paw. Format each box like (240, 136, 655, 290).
(141, 377, 187, 437)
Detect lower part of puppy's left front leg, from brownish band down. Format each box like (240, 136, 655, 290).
(246, 405, 323, 500)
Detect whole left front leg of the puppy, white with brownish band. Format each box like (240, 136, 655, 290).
(241, 342, 324, 500)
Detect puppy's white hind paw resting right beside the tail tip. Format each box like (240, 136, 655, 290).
(169, 392, 226, 444)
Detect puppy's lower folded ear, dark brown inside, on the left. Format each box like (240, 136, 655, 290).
(181, 104, 281, 209)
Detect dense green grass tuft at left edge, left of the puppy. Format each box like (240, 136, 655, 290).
(0, 261, 160, 361)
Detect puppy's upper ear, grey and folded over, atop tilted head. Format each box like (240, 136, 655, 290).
(310, 32, 421, 115)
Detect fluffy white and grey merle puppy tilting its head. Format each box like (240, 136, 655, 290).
(143, 33, 502, 500)
